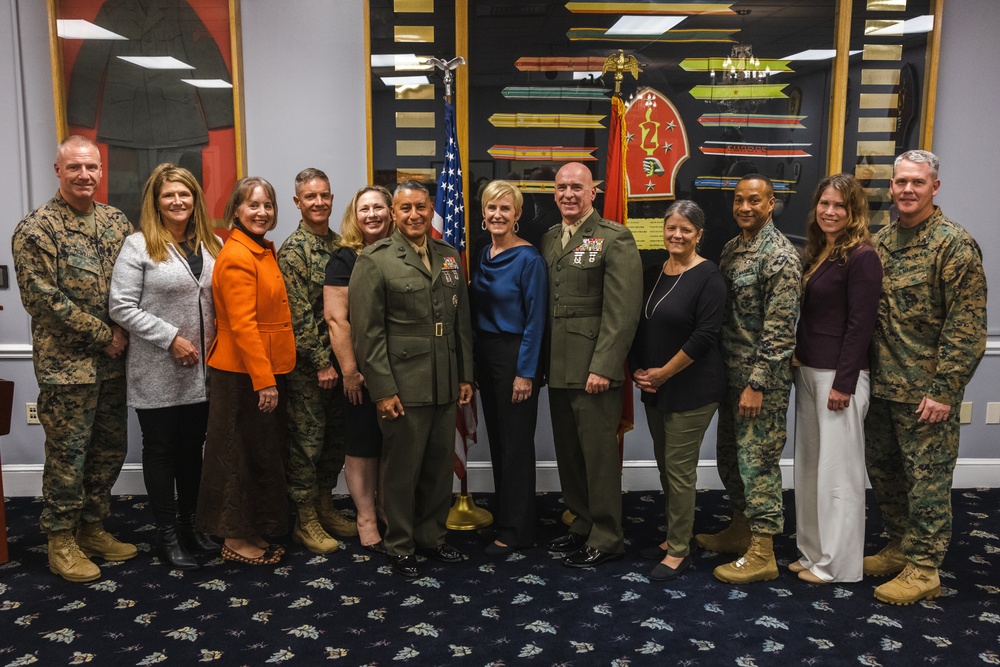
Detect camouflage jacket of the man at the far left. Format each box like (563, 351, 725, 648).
(13, 193, 133, 384)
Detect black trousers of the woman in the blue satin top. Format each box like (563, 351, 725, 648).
(475, 332, 539, 547)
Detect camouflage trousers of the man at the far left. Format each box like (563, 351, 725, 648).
(38, 377, 128, 533)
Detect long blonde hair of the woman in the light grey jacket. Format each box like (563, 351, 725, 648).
(139, 162, 222, 264)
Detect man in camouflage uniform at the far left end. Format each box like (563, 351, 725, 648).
(13, 136, 137, 581)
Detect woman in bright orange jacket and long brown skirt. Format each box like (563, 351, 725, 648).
(191, 176, 295, 565)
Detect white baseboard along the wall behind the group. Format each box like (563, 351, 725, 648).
(3, 459, 1000, 497)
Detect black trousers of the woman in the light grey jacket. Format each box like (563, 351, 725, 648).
(135, 402, 208, 528)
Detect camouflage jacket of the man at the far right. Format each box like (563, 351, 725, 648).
(872, 207, 986, 406)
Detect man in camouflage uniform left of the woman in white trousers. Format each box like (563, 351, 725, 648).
(695, 174, 802, 584)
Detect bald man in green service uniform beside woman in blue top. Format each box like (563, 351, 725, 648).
(542, 162, 642, 567)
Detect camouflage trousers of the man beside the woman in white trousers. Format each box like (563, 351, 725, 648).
(715, 387, 789, 535)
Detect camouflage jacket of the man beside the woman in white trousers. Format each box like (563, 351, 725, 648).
(719, 221, 802, 389)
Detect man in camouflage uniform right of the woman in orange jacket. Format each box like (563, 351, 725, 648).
(278, 168, 358, 554)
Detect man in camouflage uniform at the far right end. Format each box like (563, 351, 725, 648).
(864, 151, 986, 604)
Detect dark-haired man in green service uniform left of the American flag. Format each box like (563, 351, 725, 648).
(349, 181, 472, 578)
